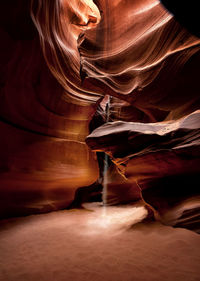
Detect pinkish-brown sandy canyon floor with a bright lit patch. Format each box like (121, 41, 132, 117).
(0, 203, 200, 281)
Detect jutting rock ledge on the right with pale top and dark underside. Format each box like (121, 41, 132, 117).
(87, 111, 200, 231)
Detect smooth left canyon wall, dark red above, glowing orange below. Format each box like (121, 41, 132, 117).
(0, 1, 98, 216)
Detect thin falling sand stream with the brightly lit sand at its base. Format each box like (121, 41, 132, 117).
(84, 96, 147, 228)
